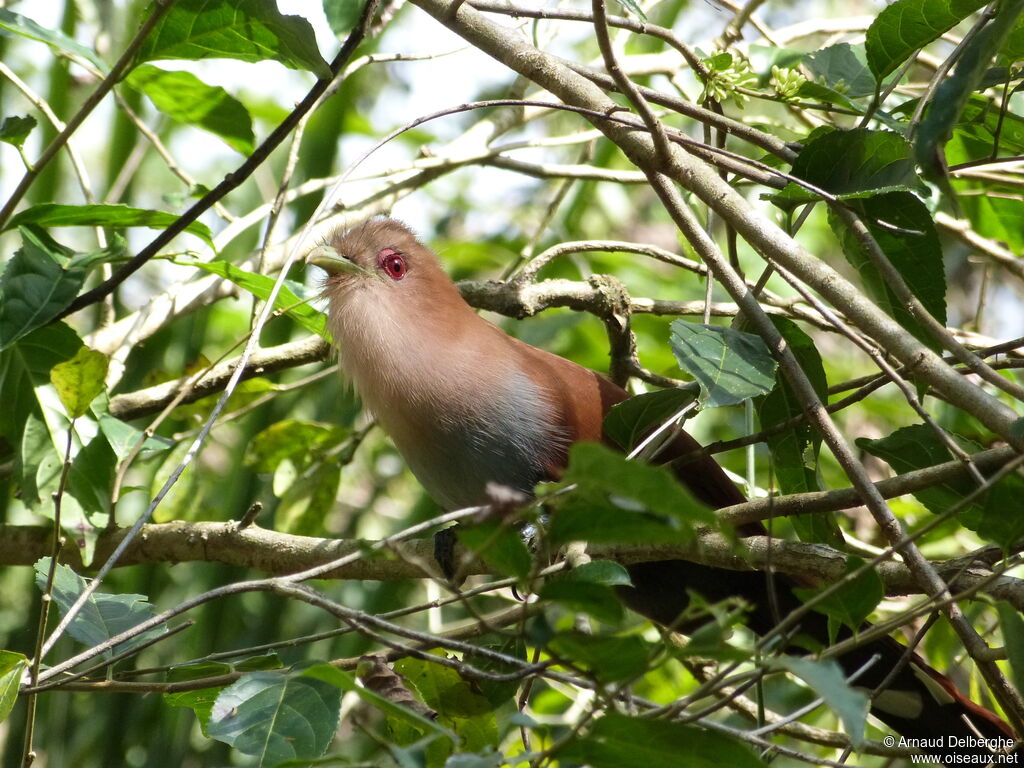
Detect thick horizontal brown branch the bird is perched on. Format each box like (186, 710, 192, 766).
(0, 521, 1024, 610)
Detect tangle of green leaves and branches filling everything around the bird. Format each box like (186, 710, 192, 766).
(0, 0, 1024, 768)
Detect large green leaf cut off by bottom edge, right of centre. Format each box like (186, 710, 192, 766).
(558, 713, 766, 768)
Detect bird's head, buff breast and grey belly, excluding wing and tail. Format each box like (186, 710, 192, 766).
(310, 220, 563, 509)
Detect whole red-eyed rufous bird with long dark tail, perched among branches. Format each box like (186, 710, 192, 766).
(307, 219, 1014, 765)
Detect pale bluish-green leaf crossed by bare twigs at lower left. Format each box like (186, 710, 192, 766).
(35, 557, 167, 658)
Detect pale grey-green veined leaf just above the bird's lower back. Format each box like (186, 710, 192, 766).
(671, 319, 776, 408)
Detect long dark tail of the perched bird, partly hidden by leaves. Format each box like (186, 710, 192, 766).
(623, 433, 1016, 765)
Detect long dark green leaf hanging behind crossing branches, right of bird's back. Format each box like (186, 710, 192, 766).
(757, 316, 844, 547)
